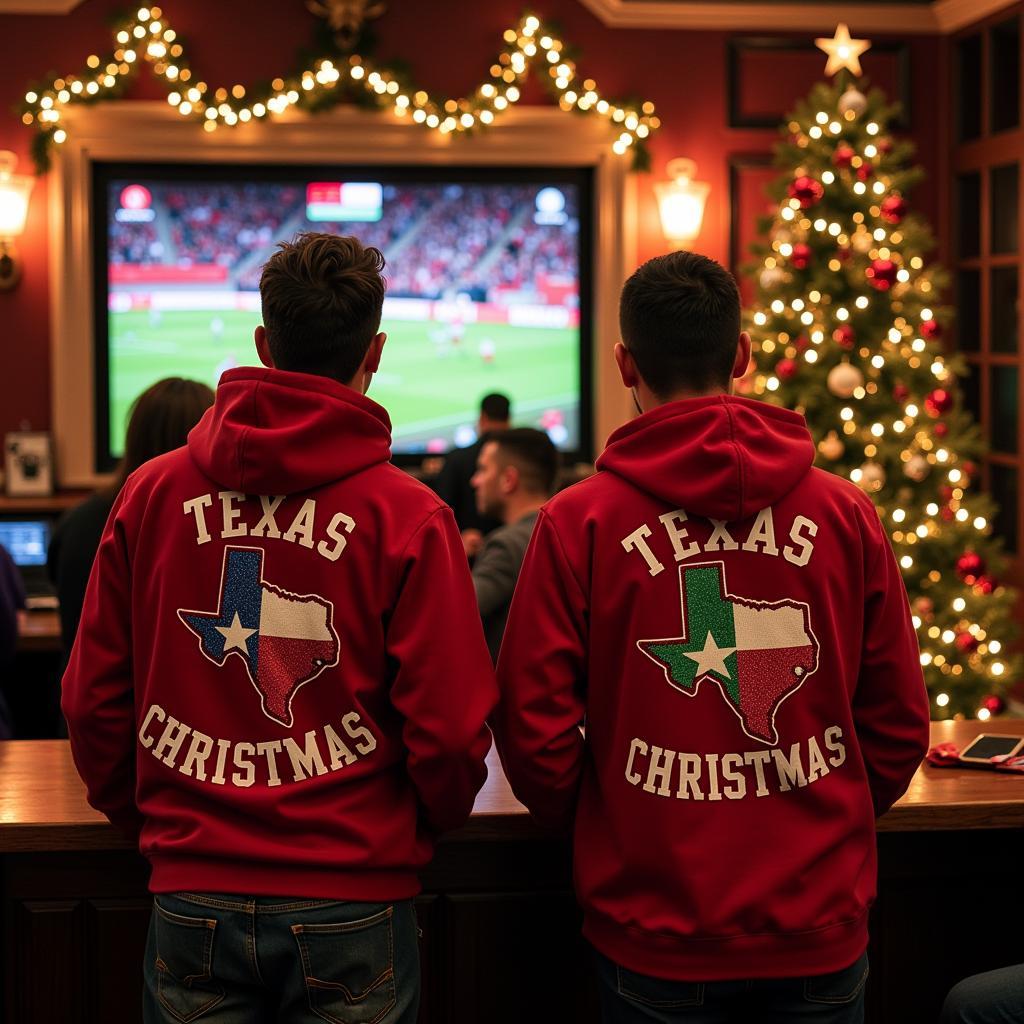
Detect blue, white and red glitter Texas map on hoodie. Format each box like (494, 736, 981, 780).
(178, 547, 341, 726)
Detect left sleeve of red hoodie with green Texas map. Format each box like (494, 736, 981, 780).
(494, 511, 587, 826)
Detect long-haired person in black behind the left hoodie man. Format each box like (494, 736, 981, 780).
(46, 377, 213, 655)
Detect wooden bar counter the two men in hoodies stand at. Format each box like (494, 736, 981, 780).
(0, 720, 1024, 1024)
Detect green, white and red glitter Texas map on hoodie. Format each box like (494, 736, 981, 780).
(637, 562, 818, 743)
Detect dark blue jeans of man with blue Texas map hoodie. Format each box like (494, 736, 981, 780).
(142, 893, 420, 1024)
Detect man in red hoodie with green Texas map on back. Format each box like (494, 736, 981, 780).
(493, 252, 928, 1024)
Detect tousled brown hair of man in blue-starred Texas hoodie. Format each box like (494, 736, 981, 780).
(259, 231, 385, 384)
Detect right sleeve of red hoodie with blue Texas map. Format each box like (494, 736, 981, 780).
(386, 507, 498, 831)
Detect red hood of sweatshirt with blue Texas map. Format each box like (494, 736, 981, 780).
(188, 367, 391, 495)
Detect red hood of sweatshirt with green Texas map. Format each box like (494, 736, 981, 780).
(597, 395, 814, 522)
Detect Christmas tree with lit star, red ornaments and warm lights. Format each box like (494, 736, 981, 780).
(743, 26, 1019, 719)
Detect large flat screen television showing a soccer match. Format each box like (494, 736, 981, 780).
(92, 163, 592, 471)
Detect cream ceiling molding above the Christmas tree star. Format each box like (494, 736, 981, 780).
(580, 0, 1015, 35)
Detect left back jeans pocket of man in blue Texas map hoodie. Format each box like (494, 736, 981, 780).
(153, 897, 224, 1024)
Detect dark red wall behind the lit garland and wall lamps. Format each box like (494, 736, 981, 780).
(0, 0, 950, 434)
